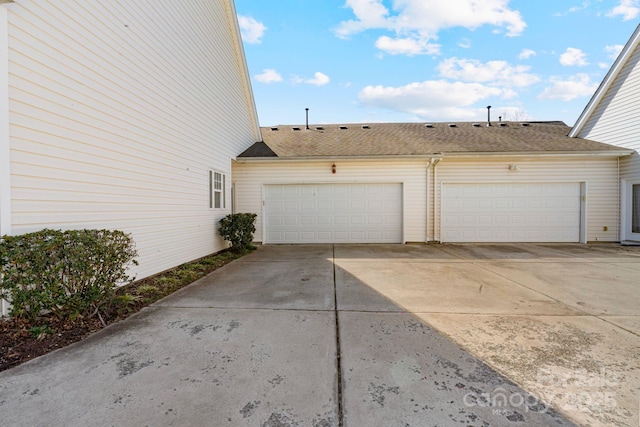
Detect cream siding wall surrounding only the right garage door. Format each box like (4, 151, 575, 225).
(430, 158, 620, 242)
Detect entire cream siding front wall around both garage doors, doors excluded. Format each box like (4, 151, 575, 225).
(233, 157, 619, 242)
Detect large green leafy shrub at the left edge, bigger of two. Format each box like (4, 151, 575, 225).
(0, 229, 137, 322)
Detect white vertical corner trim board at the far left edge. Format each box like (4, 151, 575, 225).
(0, 7, 11, 236)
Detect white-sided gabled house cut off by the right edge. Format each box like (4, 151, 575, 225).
(570, 26, 640, 242)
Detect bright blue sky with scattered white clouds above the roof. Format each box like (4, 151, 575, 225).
(235, 0, 640, 126)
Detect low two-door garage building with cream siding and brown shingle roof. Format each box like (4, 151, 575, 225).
(233, 122, 631, 243)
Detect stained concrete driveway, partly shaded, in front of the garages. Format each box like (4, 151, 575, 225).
(0, 244, 640, 426)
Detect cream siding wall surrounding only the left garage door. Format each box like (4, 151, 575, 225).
(233, 160, 429, 242)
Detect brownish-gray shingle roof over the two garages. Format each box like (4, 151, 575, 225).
(238, 122, 632, 158)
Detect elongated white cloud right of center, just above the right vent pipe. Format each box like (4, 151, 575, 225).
(437, 58, 540, 87)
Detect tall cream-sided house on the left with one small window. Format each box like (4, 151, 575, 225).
(0, 0, 261, 314)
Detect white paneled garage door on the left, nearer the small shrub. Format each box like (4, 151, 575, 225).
(265, 184, 402, 243)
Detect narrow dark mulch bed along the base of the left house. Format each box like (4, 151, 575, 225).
(0, 251, 243, 371)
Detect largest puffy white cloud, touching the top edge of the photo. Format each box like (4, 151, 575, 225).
(336, 0, 527, 55)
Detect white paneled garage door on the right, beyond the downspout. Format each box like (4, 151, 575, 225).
(441, 183, 580, 242)
